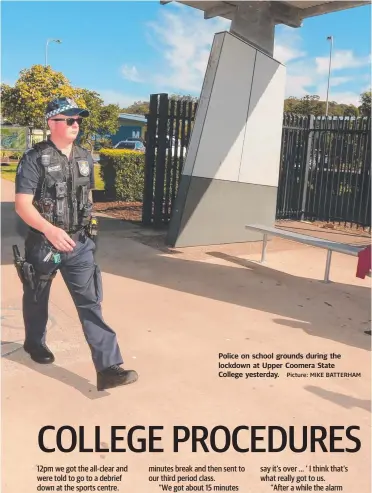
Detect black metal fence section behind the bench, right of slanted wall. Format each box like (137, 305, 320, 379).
(276, 114, 371, 228)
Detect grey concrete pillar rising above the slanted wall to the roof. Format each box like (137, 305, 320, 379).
(230, 1, 275, 56)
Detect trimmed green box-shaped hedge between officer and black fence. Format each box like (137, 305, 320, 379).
(99, 149, 145, 202)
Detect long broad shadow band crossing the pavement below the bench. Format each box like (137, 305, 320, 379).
(2, 203, 371, 350)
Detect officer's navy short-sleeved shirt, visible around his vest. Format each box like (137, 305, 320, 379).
(15, 140, 95, 195)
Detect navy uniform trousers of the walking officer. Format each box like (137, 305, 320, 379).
(23, 230, 123, 372)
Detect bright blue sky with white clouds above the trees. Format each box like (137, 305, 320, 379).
(1, 0, 371, 108)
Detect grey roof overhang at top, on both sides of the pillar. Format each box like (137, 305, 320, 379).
(160, 0, 371, 27)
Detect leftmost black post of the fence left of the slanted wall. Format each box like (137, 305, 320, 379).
(142, 94, 158, 226)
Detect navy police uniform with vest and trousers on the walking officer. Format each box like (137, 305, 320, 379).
(15, 100, 135, 390)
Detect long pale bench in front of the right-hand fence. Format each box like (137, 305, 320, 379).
(245, 224, 365, 282)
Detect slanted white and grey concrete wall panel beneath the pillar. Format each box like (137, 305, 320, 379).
(167, 32, 285, 247)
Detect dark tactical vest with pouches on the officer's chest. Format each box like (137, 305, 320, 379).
(34, 142, 92, 232)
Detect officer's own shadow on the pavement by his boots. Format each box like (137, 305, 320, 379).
(2, 342, 110, 400)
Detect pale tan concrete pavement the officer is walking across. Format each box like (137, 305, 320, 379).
(1, 180, 371, 493)
